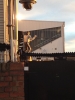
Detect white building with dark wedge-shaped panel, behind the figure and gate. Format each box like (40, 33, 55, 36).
(18, 20, 65, 53)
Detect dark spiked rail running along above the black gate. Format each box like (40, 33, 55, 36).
(20, 52, 75, 61)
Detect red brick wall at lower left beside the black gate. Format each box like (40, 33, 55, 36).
(0, 63, 24, 100)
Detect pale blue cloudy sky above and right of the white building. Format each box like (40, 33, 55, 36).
(18, 0, 75, 52)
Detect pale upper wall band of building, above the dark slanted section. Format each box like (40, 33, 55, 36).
(18, 20, 64, 31)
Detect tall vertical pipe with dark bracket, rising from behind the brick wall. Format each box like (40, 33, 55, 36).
(7, 0, 14, 62)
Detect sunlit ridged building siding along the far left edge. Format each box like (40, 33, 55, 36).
(0, 0, 9, 61)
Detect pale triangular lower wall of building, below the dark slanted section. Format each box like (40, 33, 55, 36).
(33, 37, 64, 53)
